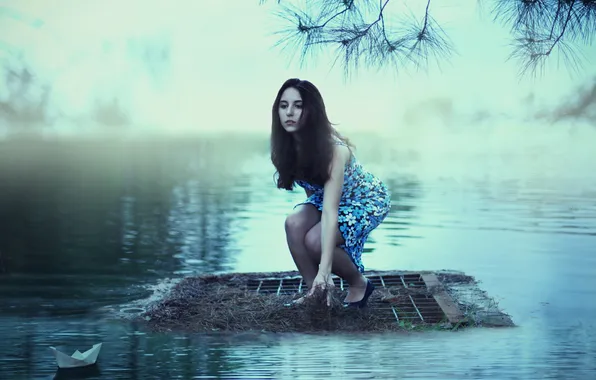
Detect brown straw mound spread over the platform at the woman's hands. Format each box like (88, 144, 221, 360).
(141, 273, 438, 332)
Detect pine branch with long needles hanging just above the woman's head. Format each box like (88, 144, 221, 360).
(264, 0, 452, 75)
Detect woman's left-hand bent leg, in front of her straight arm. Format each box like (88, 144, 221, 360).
(285, 204, 321, 288)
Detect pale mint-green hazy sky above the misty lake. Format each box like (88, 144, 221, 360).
(0, 0, 596, 131)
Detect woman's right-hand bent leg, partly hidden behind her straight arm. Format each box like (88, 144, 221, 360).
(305, 226, 367, 302)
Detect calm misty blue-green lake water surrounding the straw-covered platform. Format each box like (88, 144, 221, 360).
(0, 135, 596, 379)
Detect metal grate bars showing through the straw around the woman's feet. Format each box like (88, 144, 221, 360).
(247, 273, 463, 324)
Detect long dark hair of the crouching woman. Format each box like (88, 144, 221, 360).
(271, 78, 351, 190)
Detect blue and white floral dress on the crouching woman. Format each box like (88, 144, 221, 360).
(294, 141, 391, 273)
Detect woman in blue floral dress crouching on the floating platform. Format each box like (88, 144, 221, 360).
(271, 79, 391, 308)
